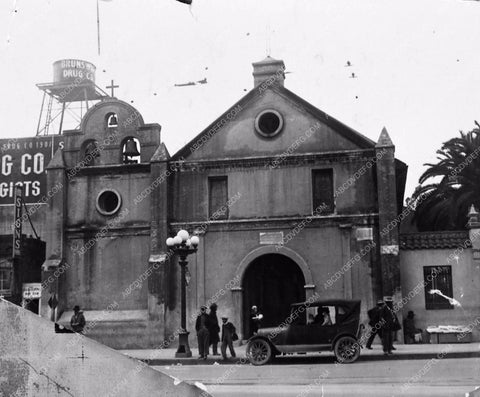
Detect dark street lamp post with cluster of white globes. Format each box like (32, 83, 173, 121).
(166, 230, 200, 357)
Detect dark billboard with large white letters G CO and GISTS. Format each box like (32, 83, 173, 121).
(0, 135, 63, 206)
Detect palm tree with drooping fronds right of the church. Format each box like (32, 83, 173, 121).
(412, 121, 480, 231)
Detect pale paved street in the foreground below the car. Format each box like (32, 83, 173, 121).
(154, 356, 480, 397)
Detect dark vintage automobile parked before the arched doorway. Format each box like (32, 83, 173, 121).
(246, 299, 363, 365)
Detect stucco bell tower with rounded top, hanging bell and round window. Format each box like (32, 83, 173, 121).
(45, 97, 166, 348)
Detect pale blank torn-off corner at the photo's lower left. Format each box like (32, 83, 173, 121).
(0, 299, 208, 397)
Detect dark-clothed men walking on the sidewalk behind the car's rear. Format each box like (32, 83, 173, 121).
(365, 299, 401, 355)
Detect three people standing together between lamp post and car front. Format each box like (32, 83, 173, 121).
(195, 303, 238, 360)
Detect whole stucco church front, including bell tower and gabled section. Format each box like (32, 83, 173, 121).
(37, 57, 407, 348)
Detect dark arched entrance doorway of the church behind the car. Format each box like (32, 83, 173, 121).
(242, 254, 305, 337)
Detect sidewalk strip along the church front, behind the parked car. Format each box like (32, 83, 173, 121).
(119, 343, 480, 365)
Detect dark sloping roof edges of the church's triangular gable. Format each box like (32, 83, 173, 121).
(172, 85, 376, 160)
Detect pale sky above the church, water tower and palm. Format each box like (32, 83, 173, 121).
(0, 0, 480, 197)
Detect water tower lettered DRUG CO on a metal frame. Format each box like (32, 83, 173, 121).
(37, 59, 108, 135)
